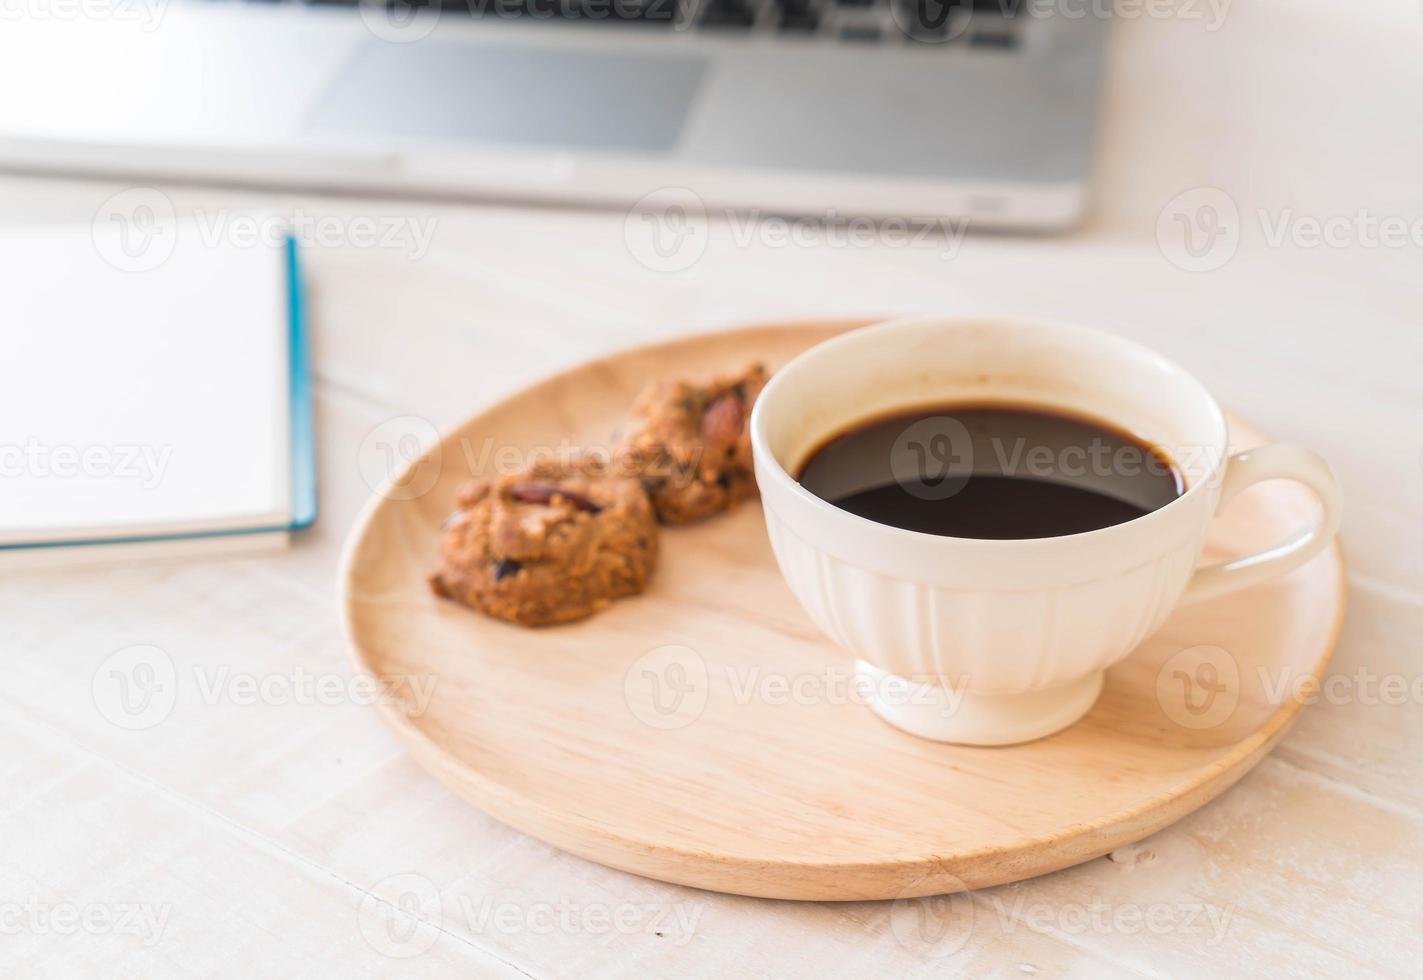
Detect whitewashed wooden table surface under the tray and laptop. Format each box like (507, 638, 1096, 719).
(0, 0, 1423, 977)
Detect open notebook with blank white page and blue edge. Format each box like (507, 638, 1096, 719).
(0, 223, 316, 566)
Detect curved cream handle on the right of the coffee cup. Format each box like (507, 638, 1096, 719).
(1181, 444, 1343, 602)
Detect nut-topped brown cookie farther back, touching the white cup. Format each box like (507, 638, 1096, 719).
(616, 364, 767, 523)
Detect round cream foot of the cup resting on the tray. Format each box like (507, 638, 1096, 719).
(855, 660, 1103, 745)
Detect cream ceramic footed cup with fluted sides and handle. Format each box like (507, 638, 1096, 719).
(751, 317, 1340, 745)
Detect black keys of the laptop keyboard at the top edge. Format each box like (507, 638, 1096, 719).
(236, 0, 1026, 51)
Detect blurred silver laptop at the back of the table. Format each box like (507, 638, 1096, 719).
(0, 0, 1107, 229)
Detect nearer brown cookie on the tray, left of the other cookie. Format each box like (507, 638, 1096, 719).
(430, 457, 657, 626)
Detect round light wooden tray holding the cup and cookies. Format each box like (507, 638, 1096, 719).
(340, 323, 1345, 900)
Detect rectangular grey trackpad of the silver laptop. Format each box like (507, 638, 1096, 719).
(305, 40, 707, 152)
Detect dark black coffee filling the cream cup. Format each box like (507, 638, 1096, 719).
(800, 405, 1184, 538)
